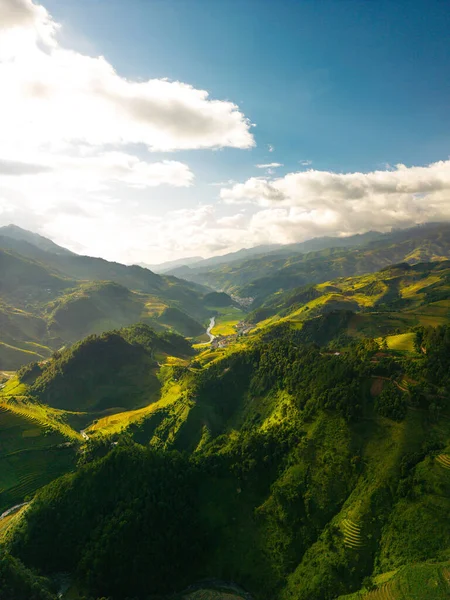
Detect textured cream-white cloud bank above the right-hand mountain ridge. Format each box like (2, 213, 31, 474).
(220, 160, 450, 242)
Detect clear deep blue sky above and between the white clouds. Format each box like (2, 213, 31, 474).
(46, 0, 450, 177)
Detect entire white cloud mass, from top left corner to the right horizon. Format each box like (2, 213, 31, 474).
(0, 0, 450, 263)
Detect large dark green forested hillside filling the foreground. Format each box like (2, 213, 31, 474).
(0, 327, 450, 600)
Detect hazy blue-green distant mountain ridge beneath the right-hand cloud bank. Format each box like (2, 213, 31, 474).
(171, 223, 450, 306)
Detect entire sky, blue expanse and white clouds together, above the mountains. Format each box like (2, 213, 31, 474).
(0, 0, 450, 264)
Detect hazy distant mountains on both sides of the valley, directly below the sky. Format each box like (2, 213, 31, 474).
(0, 224, 450, 370)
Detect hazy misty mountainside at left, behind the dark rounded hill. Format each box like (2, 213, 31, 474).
(0, 231, 211, 370)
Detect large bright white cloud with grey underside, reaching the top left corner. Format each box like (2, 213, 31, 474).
(0, 0, 254, 151)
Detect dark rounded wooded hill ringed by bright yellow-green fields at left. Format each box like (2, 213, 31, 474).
(19, 325, 192, 412)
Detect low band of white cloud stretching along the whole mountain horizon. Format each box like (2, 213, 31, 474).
(4, 159, 450, 263)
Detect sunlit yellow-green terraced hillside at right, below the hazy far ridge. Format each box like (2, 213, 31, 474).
(248, 260, 450, 337)
